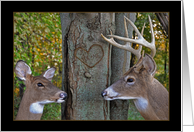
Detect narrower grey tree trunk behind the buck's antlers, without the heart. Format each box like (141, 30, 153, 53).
(110, 13, 140, 120)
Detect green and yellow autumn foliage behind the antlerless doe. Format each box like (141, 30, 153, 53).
(14, 13, 62, 120)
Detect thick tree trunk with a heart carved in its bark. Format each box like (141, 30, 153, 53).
(60, 13, 114, 120)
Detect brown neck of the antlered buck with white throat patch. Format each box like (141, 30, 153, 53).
(134, 79, 169, 120)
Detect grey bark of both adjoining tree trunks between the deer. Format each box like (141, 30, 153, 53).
(60, 13, 142, 120)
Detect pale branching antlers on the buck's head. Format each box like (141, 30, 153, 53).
(101, 16, 156, 59)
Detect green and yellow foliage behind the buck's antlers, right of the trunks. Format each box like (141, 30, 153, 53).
(135, 13, 169, 90)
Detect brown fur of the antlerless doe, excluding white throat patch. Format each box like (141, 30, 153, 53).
(15, 61, 66, 120)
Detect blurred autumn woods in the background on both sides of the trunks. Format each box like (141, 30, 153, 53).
(14, 13, 169, 120)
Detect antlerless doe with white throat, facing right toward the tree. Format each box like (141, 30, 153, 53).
(15, 60, 67, 120)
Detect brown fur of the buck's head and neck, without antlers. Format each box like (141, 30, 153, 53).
(103, 55, 169, 120)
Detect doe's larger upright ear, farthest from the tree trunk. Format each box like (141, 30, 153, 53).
(15, 60, 32, 80)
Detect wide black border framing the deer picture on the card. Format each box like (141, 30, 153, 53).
(1, 1, 181, 131)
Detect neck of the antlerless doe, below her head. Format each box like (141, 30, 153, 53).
(16, 89, 44, 120)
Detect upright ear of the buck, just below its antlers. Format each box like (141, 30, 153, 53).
(143, 54, 156, 76)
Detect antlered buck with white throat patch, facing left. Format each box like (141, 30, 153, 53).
(101, 16, 169, 120)
